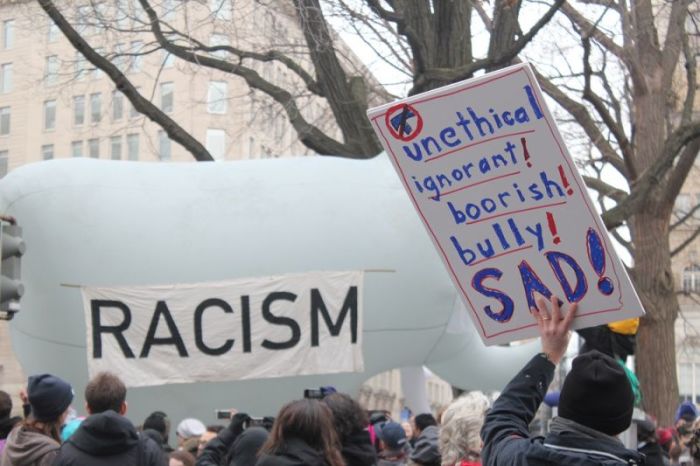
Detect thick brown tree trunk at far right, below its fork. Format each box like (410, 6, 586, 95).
(632, 212, 679, 426)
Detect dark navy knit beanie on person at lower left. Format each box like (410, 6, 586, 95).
(27, 374, 73, 421)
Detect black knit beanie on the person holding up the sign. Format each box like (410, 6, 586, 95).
(559, 350, 634, 435)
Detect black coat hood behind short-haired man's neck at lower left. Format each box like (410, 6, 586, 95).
(68, 410, 139, 456)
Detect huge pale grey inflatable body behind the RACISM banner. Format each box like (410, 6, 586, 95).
(0, 156, 537, 422)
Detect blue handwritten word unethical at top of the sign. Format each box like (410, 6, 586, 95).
(402, 86, 544, 162)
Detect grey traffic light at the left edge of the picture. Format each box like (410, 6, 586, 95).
(0, 222, 27, 320)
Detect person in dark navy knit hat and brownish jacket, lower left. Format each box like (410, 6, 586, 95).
(0, 374, 73, 466)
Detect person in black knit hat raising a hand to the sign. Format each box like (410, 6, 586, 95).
(481, 296, 644, 466)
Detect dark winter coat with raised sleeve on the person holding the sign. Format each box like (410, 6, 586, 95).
(481, 356, 644, 466)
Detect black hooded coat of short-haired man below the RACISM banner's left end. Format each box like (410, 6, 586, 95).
(53, 411, 168, 466)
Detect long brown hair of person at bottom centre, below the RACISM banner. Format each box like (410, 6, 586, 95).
(260, 398, 345, 466)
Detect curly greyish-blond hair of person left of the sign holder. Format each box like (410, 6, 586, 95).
(440, 392, 490, 466)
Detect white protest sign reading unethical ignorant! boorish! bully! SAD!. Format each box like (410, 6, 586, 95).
(368, 65, 643, 344)
